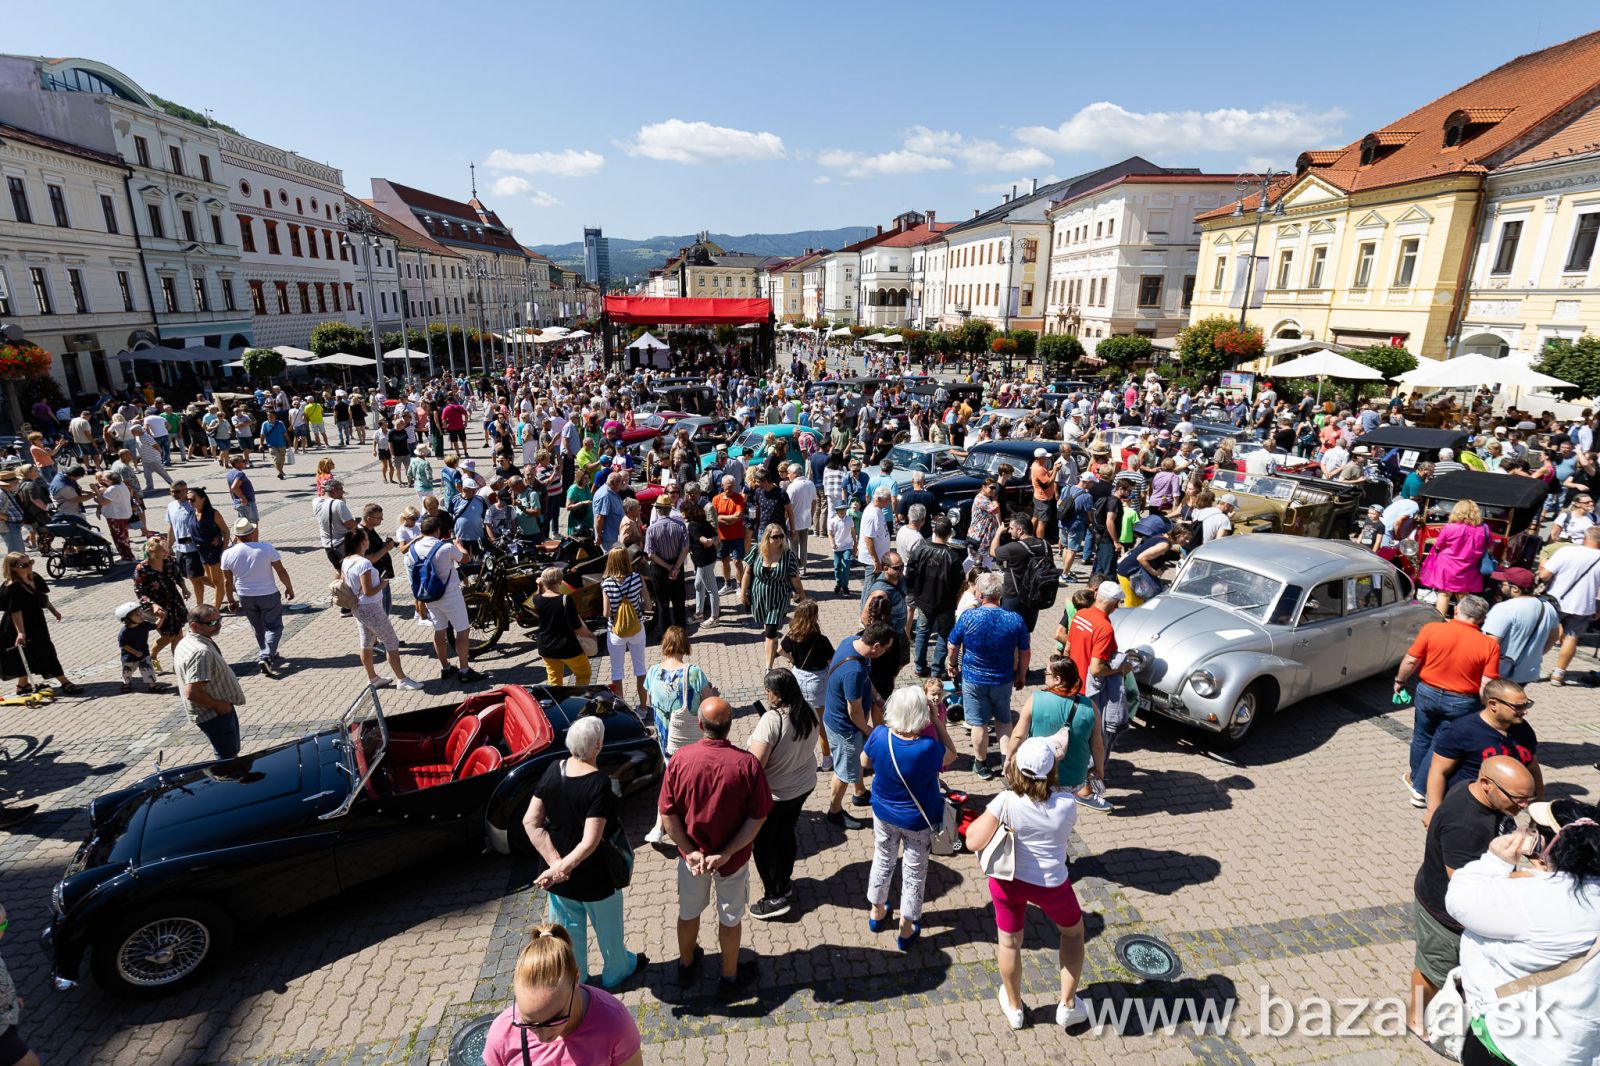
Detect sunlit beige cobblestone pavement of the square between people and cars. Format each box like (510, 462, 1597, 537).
(0, 435, 1600, 1064)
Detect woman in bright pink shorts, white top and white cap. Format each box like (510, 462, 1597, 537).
(966, 730, 1088, 1029)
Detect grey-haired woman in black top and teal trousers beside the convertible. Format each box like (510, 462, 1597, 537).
(522, 717, 646, 988)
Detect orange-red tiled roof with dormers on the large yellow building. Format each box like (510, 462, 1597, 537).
(1198, 30, 1600, 219)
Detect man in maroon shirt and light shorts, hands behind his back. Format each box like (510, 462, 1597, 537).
(659, 696, 773, 997)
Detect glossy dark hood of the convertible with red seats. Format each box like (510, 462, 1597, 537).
(130, 733, 340, 863)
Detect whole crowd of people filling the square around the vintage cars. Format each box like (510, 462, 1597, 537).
(0, 351, 1600, 1063)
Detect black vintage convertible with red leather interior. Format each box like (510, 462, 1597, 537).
(43, 685, 662, 997)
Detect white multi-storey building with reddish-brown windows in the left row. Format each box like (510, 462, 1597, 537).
(221, 133, 360, 347)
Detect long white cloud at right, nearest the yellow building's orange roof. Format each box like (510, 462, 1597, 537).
(1016, 101, 1344, 157)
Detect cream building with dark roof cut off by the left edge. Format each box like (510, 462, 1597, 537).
(0, 123, 155, 397)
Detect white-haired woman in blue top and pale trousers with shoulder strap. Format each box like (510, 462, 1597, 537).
(861, 687, 944, 951)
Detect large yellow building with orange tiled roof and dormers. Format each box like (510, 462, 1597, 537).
(1190, 34, 1600, 359)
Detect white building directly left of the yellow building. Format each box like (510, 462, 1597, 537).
(1045, 173, 1237, 341)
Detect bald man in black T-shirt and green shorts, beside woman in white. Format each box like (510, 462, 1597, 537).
(1406, 755, 1538, 1036)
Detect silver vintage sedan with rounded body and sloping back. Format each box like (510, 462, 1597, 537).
(1112, 533, 1438, 747)
